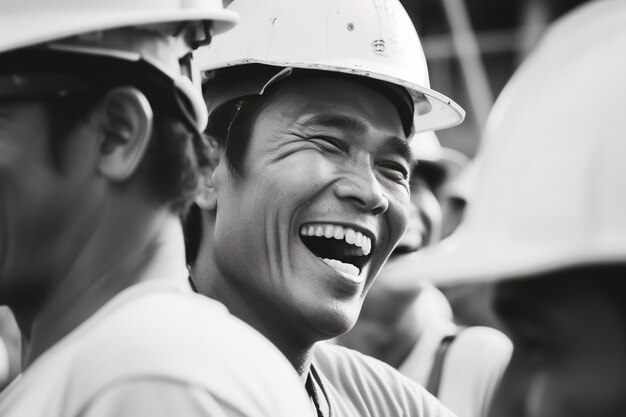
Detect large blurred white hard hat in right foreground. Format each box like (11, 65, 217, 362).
(404, 0, 626, 284)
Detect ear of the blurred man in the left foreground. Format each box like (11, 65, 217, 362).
(98, 87, 154, 181)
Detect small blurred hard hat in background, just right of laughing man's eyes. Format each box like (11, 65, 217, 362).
(411, 130, 469, 188)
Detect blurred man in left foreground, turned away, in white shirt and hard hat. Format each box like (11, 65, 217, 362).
(0, 0, 308, 417)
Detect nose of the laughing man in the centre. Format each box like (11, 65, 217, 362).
(335, 165, 389, 214)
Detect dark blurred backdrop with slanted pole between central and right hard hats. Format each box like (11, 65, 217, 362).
(402, 0, 589, 158)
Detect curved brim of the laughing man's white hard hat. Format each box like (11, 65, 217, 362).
(210, 59, 465, 133)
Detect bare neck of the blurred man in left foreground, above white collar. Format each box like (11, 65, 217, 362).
(16, 210, 185, 368)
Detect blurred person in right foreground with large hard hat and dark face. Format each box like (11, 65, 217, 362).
(408, 0, 626, 417)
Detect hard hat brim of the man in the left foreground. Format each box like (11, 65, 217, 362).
(0, 8, 238, 53)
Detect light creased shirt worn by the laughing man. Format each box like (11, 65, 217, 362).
(309, 342, 454, 417)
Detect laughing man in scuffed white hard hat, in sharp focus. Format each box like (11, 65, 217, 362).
(186, 0, 464, 416)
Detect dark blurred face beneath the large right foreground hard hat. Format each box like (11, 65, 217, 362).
(491, 271, 626, 417)
